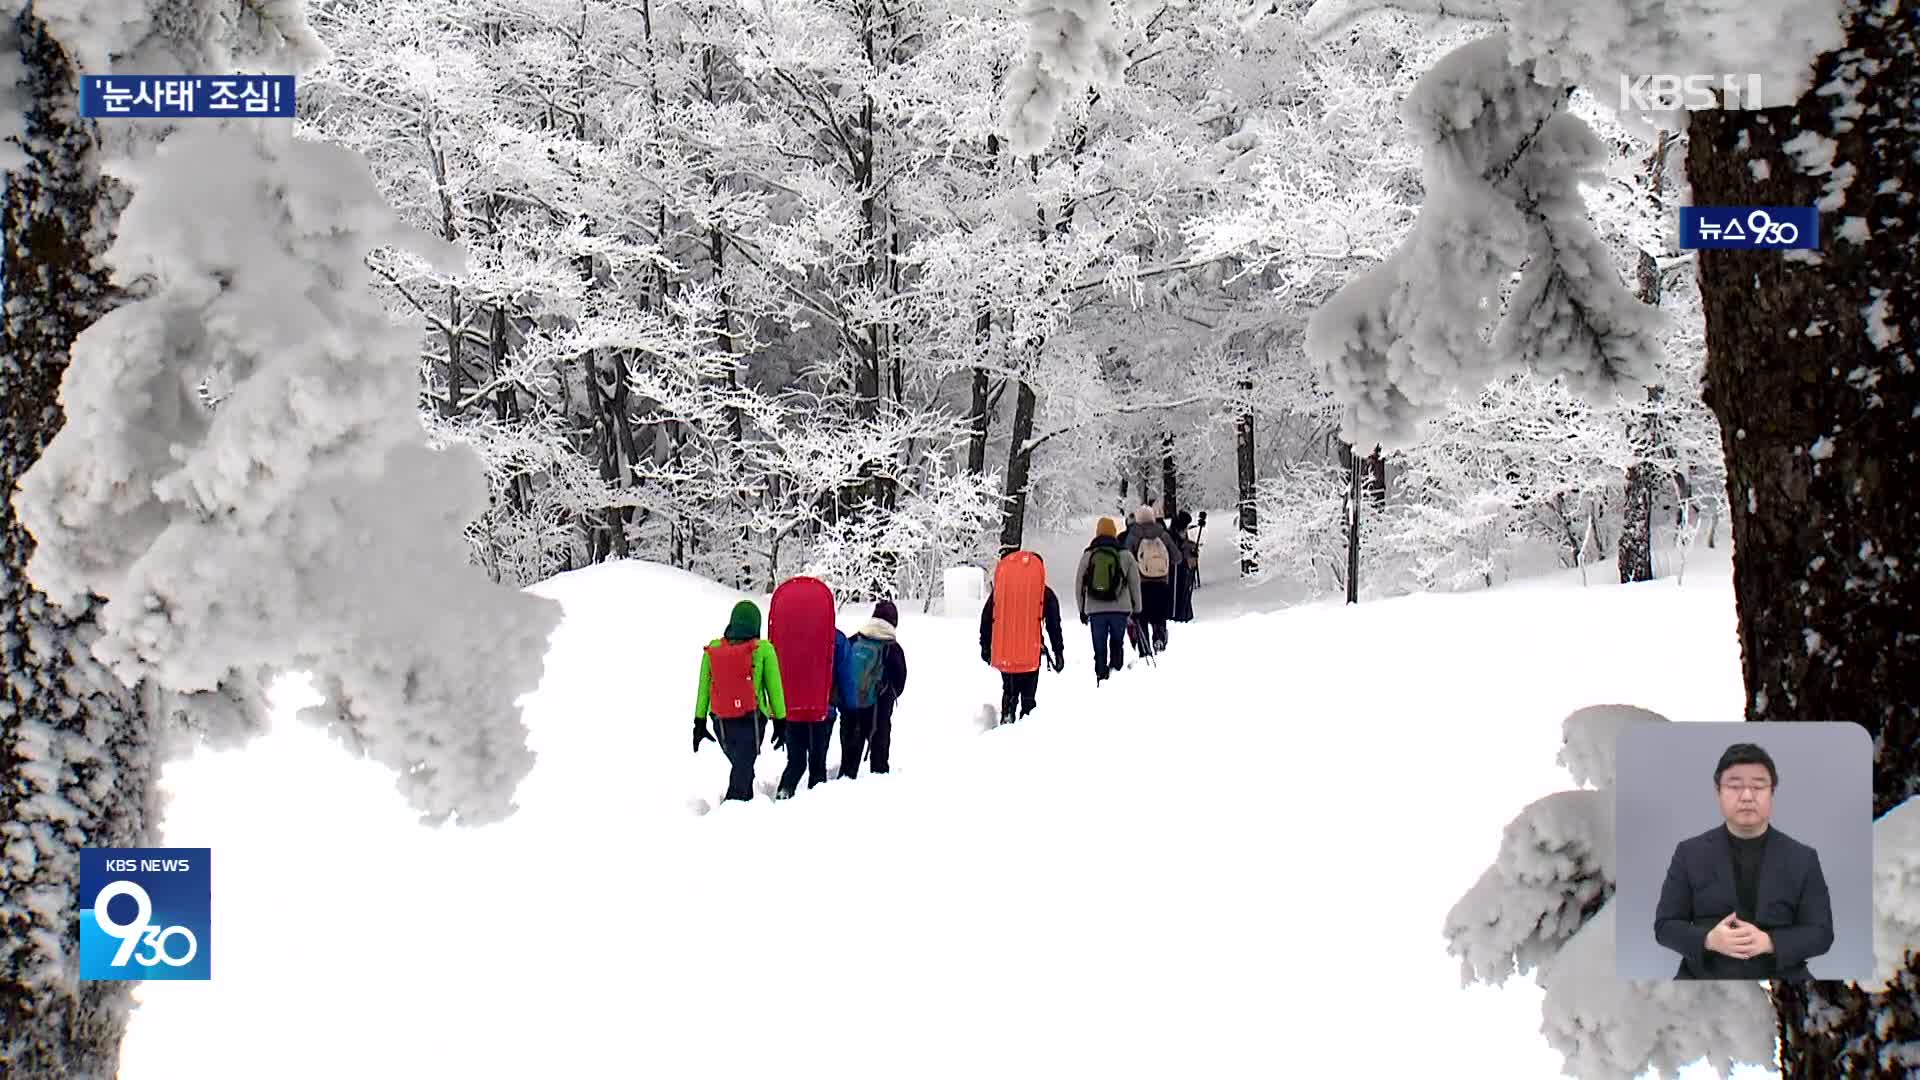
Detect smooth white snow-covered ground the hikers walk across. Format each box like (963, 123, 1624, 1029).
(121, 540, 1766, 1080)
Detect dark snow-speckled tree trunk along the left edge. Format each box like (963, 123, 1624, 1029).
(0, 13, 157, 1080)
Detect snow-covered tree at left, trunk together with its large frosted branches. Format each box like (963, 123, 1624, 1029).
(0, 2, 559, 1078)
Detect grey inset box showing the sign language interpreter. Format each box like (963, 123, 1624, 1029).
(1613, 723, 1874, 980)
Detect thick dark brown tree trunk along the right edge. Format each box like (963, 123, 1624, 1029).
(1688, 4, 1920, 1060)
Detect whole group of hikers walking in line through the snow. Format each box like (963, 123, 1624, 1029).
(693, 505, 1206, 799)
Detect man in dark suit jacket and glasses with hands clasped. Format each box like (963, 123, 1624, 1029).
(1653, 742, 1834, 980)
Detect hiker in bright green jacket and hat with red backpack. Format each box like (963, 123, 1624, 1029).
(693, 600, 787, 801)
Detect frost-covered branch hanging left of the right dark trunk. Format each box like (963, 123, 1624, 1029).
(1308, 35, 1661, 448)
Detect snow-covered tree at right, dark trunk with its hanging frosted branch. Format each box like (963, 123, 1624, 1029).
(1311, 0, 1920, 1076)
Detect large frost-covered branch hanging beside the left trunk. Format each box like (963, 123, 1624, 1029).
(17, 121, 559, 822)
